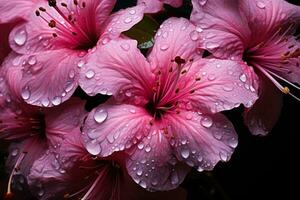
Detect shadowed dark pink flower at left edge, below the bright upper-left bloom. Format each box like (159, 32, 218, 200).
(0, 79, 86, 198)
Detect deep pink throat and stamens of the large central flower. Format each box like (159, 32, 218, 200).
(146, 56, 200, 120)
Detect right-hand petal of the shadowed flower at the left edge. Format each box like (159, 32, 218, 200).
(44, 98, 87, 147)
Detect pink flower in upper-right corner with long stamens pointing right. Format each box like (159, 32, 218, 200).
(191, 0, 300, 135)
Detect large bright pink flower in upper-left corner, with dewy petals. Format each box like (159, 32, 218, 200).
(1, 0, 144, 107)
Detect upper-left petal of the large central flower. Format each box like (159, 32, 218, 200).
(79, 39, 154, 99)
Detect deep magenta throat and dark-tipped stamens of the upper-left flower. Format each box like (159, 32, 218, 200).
(35, 0, 98, 50)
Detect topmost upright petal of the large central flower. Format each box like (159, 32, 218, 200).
(148, 18, 201, 73)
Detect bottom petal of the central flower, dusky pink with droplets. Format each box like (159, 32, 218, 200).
(127, 127, 189, 191)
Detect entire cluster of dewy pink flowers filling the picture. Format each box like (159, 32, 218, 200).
(0, 0, 300, 200)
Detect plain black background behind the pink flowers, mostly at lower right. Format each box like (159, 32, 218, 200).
(0, 0, 300, 200)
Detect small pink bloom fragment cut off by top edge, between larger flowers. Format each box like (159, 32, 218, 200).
(138, 0, 182, 13)
